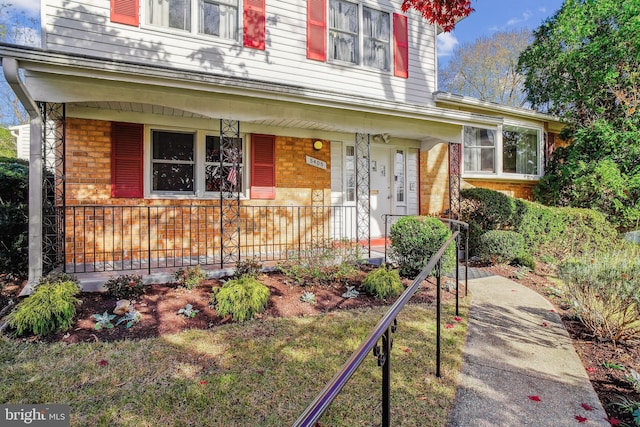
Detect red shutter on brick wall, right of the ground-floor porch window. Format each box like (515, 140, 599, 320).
(251, 135, 276, 199)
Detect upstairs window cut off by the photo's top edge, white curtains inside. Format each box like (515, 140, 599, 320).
(147, 0, 238, 40)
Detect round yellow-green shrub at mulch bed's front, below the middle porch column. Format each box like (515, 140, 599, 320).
(211, 276, 270, 322)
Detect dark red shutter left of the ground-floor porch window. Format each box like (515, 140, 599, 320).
(111, 123, 144, 197)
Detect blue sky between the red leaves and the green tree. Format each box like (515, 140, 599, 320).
(438, 0, 563, 65)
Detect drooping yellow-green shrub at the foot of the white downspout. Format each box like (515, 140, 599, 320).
(8, 281, 80, 336)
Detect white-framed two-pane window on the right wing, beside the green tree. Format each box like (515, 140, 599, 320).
(463, 125, 541, 176)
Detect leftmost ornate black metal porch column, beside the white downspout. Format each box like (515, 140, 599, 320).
(38, 102, 66, 274)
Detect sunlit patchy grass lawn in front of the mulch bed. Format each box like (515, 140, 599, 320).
(0, 303, 467, 427)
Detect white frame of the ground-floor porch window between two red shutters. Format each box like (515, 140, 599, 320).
(143, 125, 251, 200)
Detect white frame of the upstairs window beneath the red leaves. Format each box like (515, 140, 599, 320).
(326, 0, 393, 73)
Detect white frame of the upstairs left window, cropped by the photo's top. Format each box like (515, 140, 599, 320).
(141, 0, 243, 43)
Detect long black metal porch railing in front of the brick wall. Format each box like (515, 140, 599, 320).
(64, 205, 356, 273)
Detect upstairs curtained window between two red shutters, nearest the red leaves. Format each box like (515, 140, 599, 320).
(328, 0, 391, 71)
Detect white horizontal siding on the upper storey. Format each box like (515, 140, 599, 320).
(43, 0, 436, 105)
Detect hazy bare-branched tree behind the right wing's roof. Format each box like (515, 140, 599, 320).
(438, 29, 531, 107)
